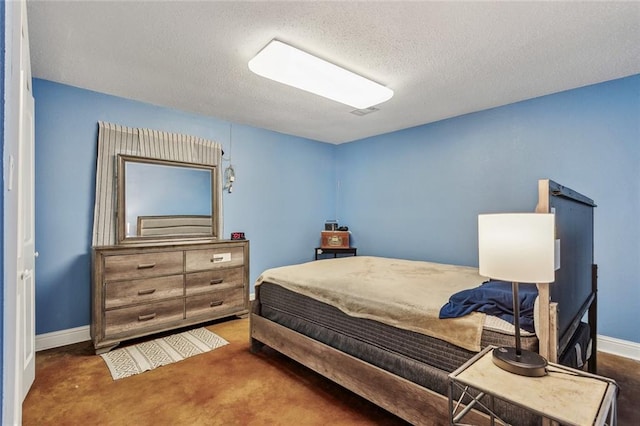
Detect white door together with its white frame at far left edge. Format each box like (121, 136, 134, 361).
(2, 0, 36, 425)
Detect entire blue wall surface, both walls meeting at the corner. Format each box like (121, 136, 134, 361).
(34, 76, 640, 342)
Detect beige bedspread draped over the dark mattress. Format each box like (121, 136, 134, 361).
(256, 256, 487, 351)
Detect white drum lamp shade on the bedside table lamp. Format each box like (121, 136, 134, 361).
(478, 213, 555, 283)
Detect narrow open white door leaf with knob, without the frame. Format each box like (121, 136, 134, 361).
(15, 2, 36, 403)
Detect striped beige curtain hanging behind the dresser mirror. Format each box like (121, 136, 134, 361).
(92, 121, 223, 246)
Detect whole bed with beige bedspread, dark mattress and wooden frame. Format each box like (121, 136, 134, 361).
(250, 179, 597, 424)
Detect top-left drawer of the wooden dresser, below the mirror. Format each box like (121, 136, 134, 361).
(104, 251, 183, 281)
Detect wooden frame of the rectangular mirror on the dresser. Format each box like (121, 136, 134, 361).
(116, 154, 222, 244)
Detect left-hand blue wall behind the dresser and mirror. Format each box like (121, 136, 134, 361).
(33, 79, 335, 334)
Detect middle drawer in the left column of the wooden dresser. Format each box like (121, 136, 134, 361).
(104, 275, 184, 309)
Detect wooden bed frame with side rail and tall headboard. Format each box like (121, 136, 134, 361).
(250, 180, 597, 425)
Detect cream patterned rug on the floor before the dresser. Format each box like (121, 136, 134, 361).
(100, 328, 229, 380)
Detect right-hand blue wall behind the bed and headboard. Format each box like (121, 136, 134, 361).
(336, 75, 640, 342)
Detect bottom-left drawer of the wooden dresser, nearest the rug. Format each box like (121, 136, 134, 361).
(104, 298, 184, 336)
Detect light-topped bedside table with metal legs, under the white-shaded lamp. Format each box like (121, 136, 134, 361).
(449, 346, 618, 425)
